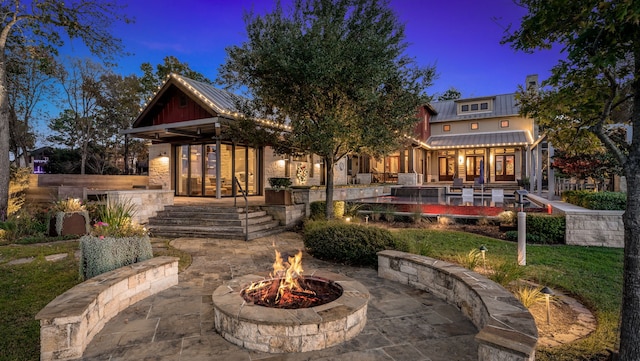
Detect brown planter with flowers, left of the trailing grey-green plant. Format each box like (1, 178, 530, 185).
(48, 198, 91, 237)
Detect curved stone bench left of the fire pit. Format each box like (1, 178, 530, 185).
(36, 257, 178, 361)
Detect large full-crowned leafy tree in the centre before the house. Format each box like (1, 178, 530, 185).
(218, 0, 434, 218)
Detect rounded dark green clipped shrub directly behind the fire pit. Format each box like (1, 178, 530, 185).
(303, 221, 395, 266)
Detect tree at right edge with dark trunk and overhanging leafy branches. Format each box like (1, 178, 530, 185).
(503, 0, 640, 360)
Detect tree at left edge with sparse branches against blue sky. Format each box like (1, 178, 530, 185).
(0, 0, 129, 221)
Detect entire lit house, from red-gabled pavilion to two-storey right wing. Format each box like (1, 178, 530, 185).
(122, 74, 538, 198)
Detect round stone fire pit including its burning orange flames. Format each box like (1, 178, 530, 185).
(213, 252, 369, 353)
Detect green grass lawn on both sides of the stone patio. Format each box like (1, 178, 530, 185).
(0, 229, 623, 361)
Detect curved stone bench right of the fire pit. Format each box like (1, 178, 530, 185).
(378, 251, 538, 361)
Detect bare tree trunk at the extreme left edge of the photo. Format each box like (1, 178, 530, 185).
(0, 57, 11, 221)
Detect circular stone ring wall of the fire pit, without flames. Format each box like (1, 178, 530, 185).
(212, 270, 369, 353)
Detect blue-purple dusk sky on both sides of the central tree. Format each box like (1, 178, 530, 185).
(72, 0, 560, 97)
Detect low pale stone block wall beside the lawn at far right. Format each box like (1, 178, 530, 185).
(564, 209, 624, 248)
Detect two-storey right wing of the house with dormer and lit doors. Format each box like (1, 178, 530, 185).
(425, 75, 546, 184)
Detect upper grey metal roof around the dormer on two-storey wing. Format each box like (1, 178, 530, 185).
(430, 93, 520, 123)
